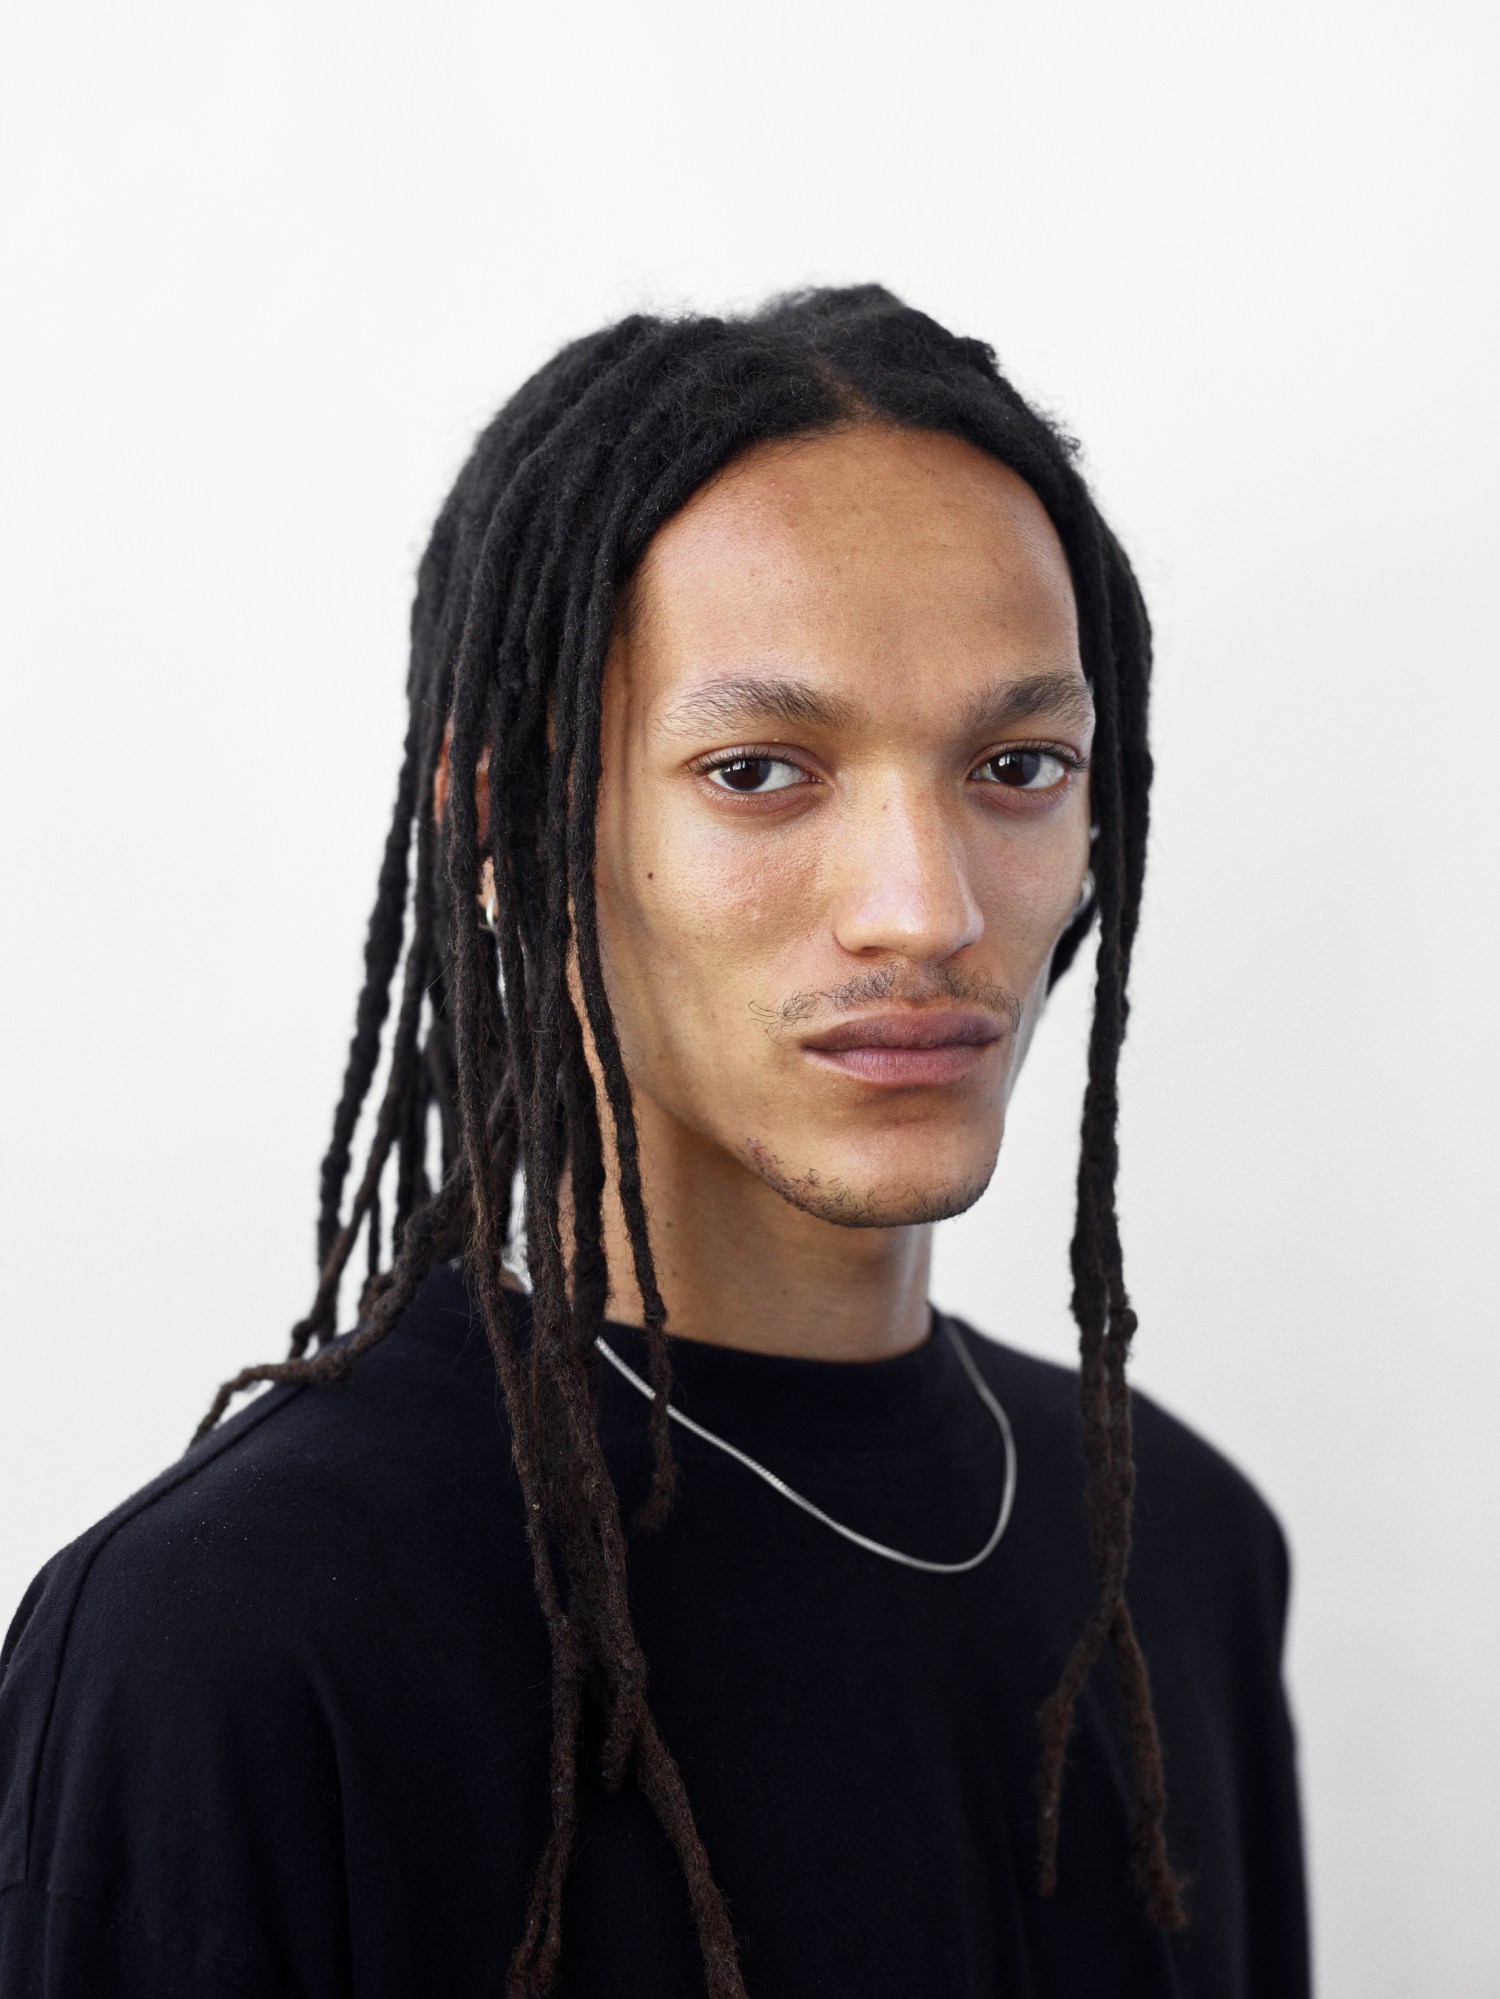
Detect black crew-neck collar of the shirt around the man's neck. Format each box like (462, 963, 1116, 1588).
(414, 1263, 992, 1451)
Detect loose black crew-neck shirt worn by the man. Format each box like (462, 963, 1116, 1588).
(0, 1267, 1308, 1999)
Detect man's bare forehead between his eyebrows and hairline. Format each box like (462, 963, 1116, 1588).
(622, 424, 1078, 708)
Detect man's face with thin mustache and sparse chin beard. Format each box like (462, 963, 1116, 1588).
(598, 428, 1092, 1227)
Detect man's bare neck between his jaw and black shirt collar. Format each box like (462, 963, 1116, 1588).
(562, 1099, 932, 1361)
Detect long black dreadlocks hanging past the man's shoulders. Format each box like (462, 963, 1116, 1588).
(198, 286, 1184, 1999)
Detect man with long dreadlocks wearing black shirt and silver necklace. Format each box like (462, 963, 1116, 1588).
(0, 288, 1306, 1999)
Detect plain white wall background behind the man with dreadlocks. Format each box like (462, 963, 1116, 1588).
(0, 0, 1500, 1999)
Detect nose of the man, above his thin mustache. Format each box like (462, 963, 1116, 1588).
(832, 784, 984, 964)
